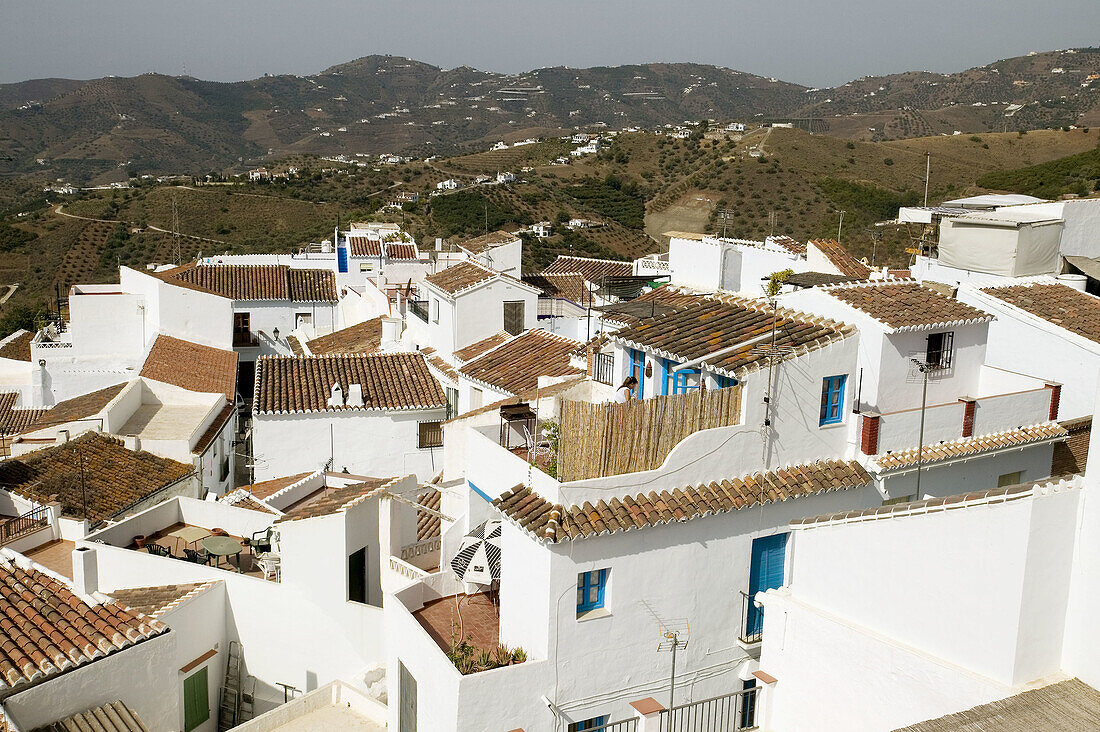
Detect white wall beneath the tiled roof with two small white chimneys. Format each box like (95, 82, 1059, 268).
(252, 409, 446, 480)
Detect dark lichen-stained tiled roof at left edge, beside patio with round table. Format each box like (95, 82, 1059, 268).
(0, 431, 195, 524)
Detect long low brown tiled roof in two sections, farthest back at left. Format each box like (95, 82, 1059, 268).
(167, 264, 337, 303)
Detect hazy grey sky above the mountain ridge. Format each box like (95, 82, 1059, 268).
(0, 0, 1100, 86)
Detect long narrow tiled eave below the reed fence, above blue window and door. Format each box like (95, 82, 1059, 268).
(493, 460, 871, 542)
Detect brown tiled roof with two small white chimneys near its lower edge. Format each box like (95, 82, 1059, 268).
(254, 353, 447, 414)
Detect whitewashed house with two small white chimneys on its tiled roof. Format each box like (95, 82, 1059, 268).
(252, 353, 447, 480)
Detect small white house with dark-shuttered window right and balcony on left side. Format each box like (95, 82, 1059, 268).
(406, 261, 539, 362)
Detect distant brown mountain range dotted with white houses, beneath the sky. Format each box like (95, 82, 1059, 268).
(0, 48, 1100, 182)
